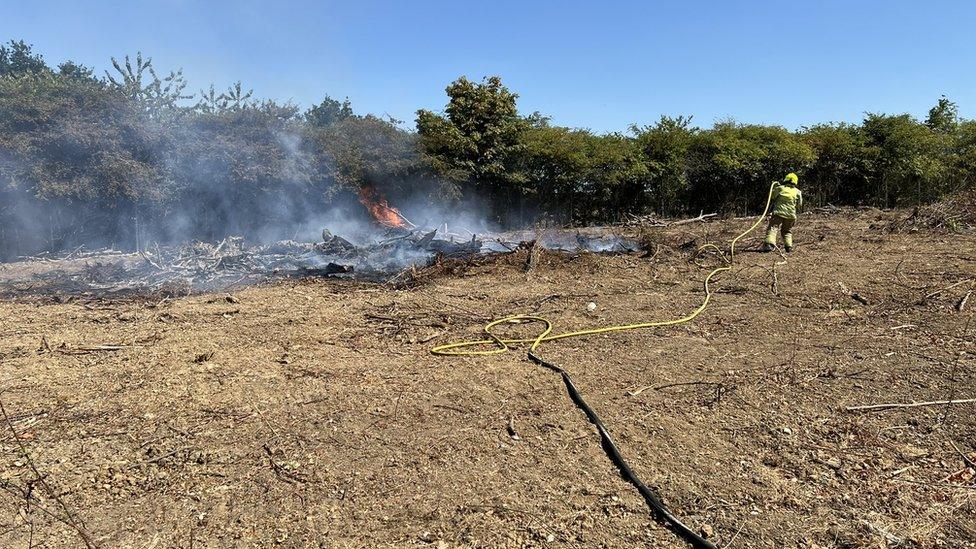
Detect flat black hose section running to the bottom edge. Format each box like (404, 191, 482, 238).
(529, 351, 717, 549)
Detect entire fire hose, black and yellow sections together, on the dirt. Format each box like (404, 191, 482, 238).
(430, 183, 776, 549)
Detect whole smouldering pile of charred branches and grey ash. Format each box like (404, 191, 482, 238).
(0, 228, 634, 295)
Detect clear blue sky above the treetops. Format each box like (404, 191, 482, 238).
(0, 0, 976, 131)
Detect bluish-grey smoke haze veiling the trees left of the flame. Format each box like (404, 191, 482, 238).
(0, 82, 510, 266)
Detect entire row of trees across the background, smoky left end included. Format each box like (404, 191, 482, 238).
(0, 41, 976, 258)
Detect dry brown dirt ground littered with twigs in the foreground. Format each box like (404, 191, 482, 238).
(0, 211, 976, 547)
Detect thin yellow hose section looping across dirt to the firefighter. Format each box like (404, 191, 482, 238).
(430, 183, 776, 356)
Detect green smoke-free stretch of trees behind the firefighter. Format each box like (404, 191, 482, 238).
(417, 78, 976, 223)
